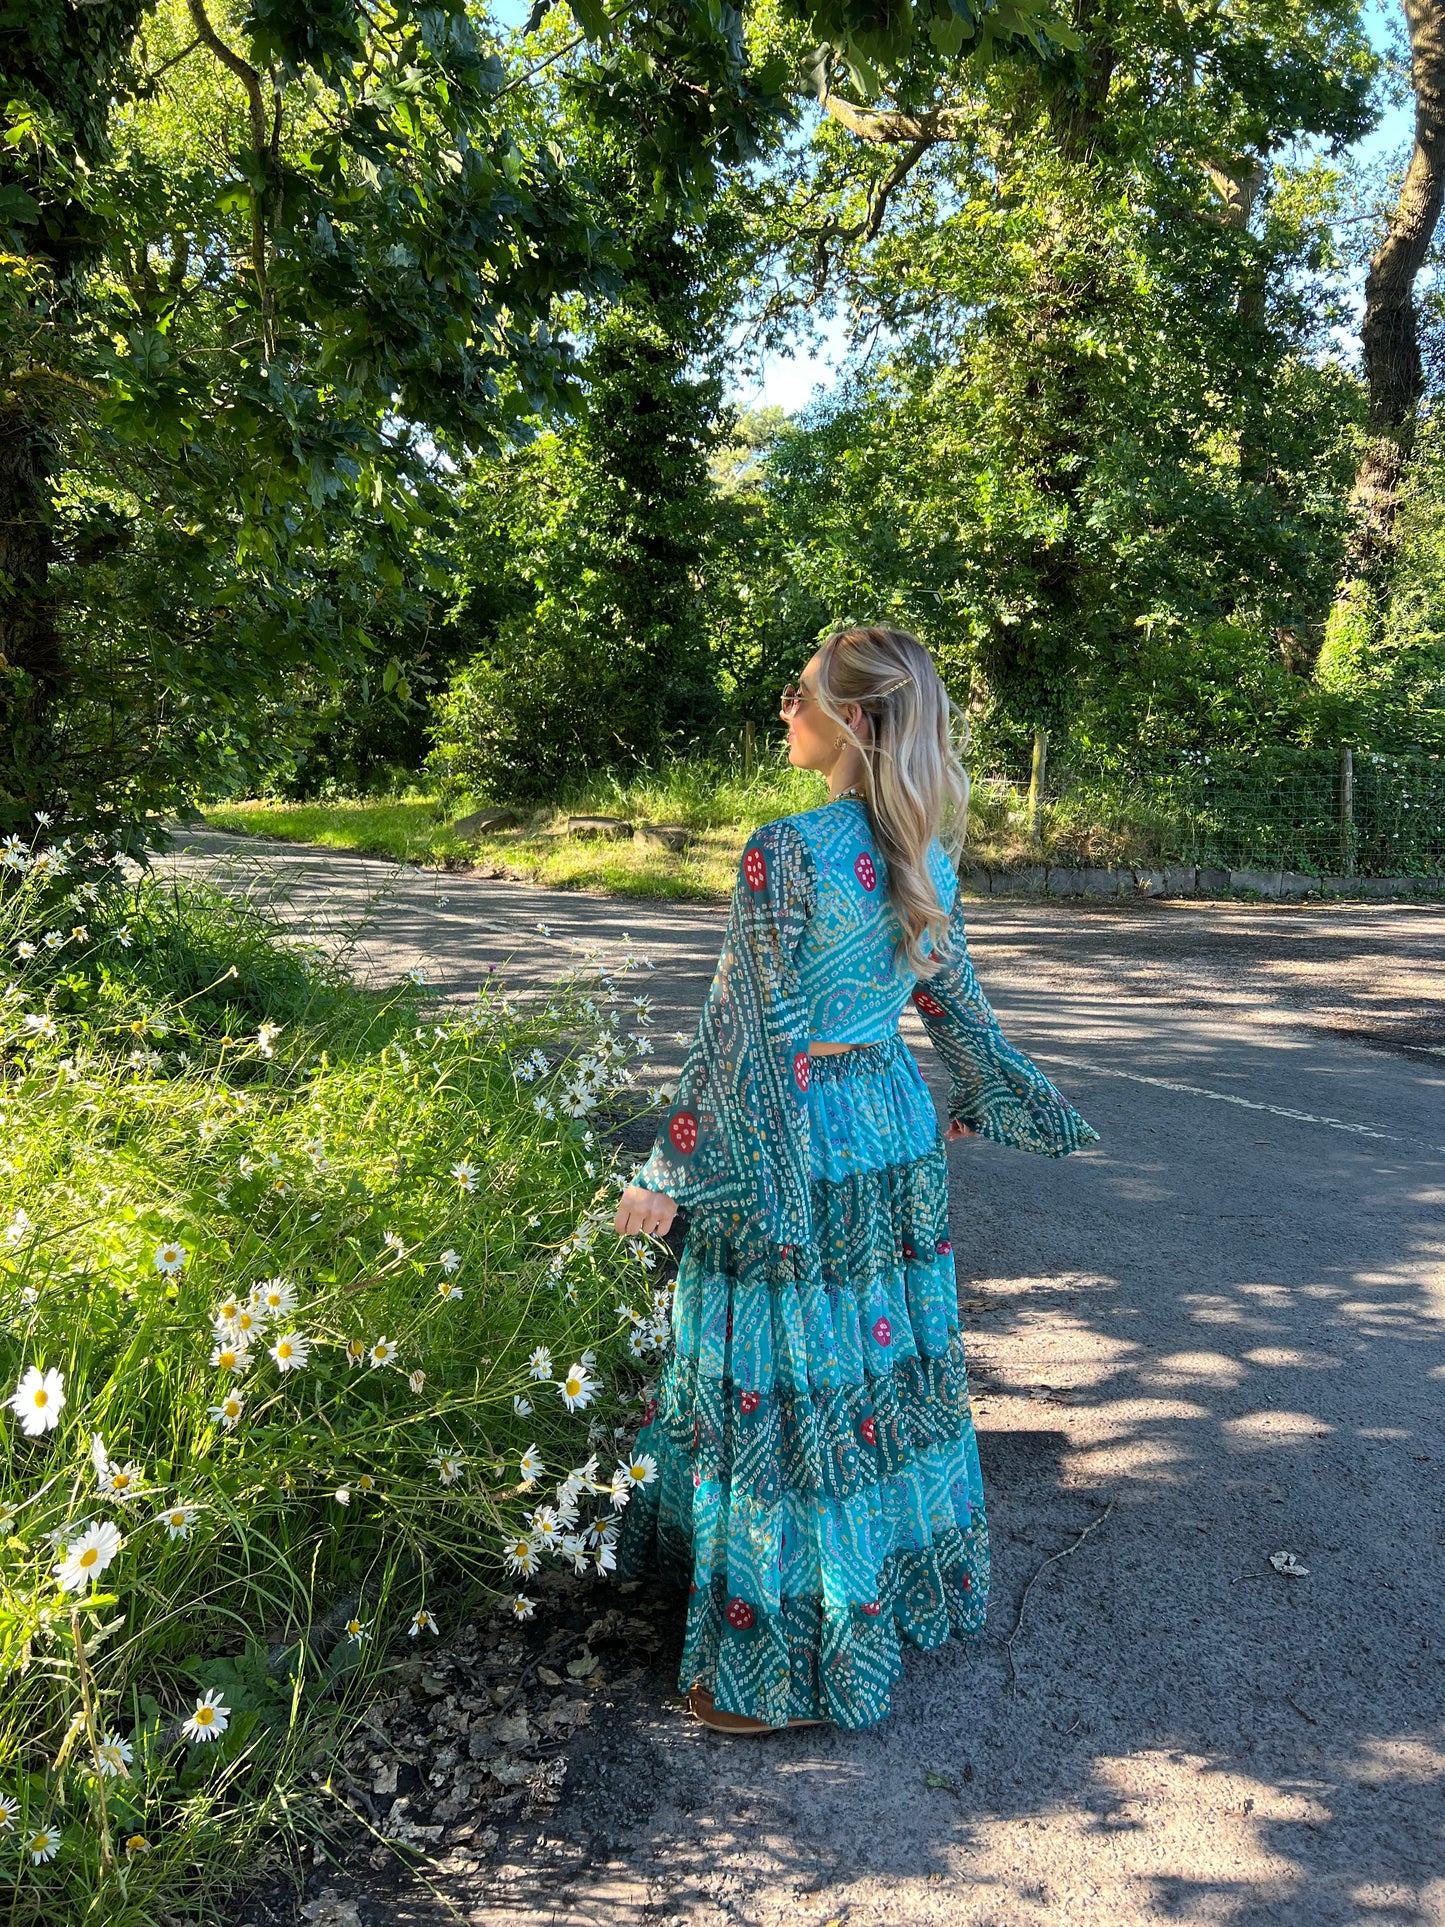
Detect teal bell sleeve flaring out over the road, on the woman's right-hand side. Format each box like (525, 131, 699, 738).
(913, 890, 1098, 1158)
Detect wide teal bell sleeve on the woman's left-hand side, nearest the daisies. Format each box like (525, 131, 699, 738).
(632, 817, 817, 1245)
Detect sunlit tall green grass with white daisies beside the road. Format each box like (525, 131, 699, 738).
(0, 846, 678, 1927)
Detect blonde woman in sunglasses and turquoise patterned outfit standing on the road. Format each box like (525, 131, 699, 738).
(617, 628, 1096, 1732)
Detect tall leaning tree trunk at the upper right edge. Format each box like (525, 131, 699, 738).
(1345, 0, 1445, 580)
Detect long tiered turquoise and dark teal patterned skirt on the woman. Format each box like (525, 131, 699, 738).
(618, 1035, 988, 1727)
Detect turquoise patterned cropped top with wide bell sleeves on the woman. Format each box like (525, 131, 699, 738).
(634, 798, 1098, 1247)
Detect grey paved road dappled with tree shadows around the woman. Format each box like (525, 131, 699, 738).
(172, 838, 1445, 1927)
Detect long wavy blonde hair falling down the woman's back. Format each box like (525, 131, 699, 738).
(815, 628, 969, 977)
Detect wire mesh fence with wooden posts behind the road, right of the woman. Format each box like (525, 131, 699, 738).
(975, 750, 1445, 877)
